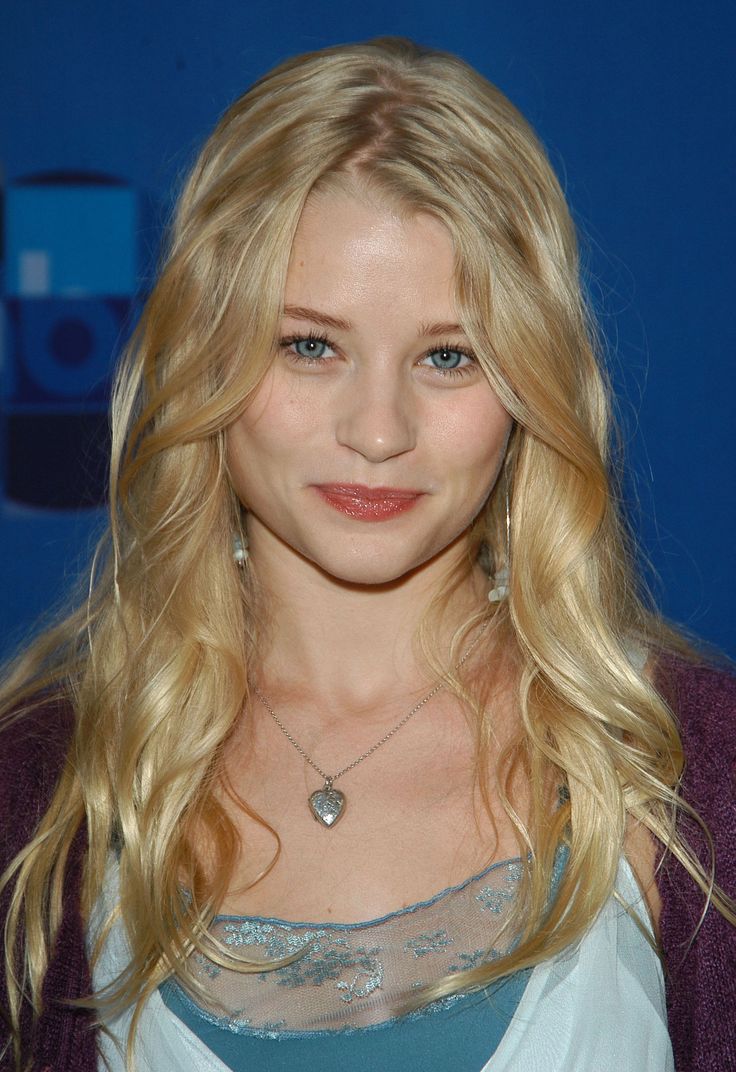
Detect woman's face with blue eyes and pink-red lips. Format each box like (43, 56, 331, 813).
(228, 189, 511, 584)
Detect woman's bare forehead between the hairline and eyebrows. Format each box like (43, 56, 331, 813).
(285, 185, 455, 318)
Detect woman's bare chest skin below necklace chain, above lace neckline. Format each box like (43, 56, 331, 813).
(216, 703, 527, 923)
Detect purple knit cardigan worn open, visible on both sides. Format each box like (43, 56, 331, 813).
(0, 659, 736, 1072)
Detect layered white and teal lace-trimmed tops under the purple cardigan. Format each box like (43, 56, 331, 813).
(89, 852, 674, 1072)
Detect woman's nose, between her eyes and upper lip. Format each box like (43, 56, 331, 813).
(335, 369, 416, 462)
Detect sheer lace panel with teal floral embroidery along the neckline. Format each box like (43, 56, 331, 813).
(173, 860, 522, 1037)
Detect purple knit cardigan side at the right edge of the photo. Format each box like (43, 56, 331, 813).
(658, 659, 736, 1072)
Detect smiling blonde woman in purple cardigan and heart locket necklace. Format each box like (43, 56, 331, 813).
(0, 39, 736, 1072)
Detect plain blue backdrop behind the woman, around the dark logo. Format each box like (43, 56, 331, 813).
(0, 0, 736, 654)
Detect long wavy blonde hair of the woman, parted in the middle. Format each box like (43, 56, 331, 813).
(2, 39, 732, 1068)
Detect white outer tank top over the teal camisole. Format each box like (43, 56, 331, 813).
(92, 861, 674, 1072)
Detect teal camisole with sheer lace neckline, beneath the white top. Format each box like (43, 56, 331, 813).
(160, 860, 529, 1072)
